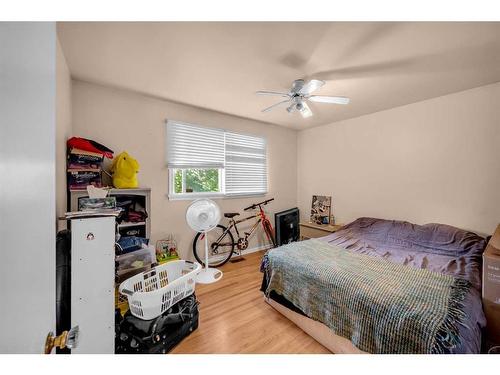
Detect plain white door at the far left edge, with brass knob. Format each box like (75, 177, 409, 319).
(0, 22, 56, 353)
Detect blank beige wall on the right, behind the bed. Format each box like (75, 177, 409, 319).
(298, 83, 500, 234)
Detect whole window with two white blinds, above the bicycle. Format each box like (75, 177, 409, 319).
(167, 121, 267, 199)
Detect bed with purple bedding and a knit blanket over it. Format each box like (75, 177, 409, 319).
(261, 218, 487, 353)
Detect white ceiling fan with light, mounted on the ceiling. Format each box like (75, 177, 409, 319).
(256, 79, 350, 118)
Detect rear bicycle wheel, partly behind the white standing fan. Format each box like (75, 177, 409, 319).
(193, 225, 234, 267)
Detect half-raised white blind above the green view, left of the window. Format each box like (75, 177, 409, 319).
(167, 121, 224, 169)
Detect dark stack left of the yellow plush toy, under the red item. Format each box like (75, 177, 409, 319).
(67, 148, 104, 190)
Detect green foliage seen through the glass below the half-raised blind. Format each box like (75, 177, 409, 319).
(174, 169, 220, 194)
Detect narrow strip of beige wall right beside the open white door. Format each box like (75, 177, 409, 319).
(56, 40, 72, 230)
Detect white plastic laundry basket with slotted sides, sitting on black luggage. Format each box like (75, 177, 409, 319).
(118, 260, 201, 320)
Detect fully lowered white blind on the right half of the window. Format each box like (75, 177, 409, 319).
(225, 132, 267, 195)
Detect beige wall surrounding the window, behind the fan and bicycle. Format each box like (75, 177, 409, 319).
(72, 81, 297, 258)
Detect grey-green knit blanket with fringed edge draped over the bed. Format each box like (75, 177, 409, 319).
(266, 239, 470, 353)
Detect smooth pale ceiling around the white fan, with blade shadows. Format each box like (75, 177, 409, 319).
(58, 22, 500, 129)
